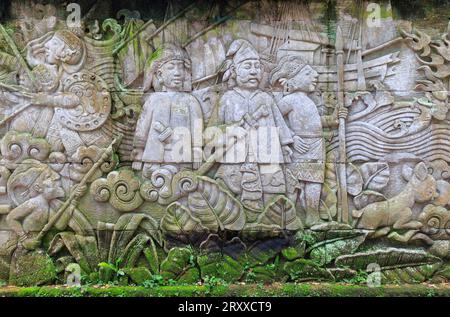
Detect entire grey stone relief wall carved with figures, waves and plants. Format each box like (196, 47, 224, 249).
(0, 0, 450, 285)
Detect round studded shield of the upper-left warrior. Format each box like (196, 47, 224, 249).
(55, 72, 111, 131)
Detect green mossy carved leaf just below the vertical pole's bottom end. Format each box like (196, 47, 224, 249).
(308, 232, 367, 266)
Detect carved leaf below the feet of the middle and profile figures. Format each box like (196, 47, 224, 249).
(257, 196, 303, 231)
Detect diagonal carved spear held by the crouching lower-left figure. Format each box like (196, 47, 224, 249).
(35, 134, 123, 242)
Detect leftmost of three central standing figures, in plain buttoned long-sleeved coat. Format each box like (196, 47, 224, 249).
(133, 44, 203, 176)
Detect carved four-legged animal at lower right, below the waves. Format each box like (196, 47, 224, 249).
(352, 162, 437, 242)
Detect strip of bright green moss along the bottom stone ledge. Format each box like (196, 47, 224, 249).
(0, 283, 450, 297)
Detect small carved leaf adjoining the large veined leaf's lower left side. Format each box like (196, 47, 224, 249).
(161, 202, 208, 236)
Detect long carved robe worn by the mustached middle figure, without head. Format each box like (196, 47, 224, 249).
(218, 88, 292, 207)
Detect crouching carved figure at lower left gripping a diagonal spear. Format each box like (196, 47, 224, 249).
(6, 159, 91, 250)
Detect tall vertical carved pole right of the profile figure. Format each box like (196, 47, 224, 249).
(335, 26, 349, 223)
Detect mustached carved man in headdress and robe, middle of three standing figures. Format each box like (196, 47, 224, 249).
(218, 39, 293, 210)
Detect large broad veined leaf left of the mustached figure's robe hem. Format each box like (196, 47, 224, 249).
(188, 176, 245, 232)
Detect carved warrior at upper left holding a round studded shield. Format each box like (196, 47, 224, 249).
(27, 30, 111, 156)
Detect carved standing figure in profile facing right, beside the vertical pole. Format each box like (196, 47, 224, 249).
(270, 56, 347, 226)
